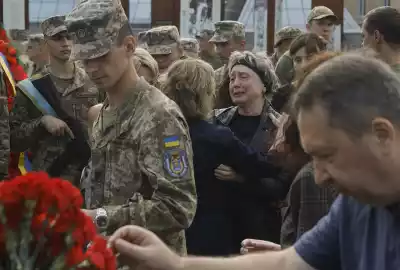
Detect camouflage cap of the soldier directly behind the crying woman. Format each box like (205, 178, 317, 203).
(210, 21, 246, 42)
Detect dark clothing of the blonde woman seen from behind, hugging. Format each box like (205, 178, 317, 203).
(186, 119, 280, 256)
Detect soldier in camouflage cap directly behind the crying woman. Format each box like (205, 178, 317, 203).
(210, 21, 245, 109)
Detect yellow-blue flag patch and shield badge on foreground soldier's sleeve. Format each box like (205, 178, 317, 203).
(164, 136, 188, 177)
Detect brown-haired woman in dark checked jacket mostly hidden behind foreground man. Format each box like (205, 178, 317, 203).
(242, 52, 339, 254)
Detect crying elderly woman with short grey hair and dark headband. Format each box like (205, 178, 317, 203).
(213, 51, 291, 247)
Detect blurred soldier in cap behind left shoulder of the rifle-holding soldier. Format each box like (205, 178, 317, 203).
(26, 34, 49, 77)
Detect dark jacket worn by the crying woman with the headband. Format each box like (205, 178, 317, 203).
(213, 101, 291, 245)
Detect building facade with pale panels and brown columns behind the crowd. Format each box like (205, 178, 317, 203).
(0, 0, 400, 50)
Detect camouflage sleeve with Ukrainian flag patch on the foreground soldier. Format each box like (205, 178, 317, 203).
(104, 108, 196, 234)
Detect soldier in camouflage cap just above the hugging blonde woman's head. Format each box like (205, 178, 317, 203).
(144, 25, 185, 89)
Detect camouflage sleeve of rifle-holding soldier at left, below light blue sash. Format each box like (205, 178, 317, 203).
(10, 90, 47, 152)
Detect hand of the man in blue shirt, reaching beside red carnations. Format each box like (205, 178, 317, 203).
(109, 225, 181, 270)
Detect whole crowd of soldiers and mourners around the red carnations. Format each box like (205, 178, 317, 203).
(0, 0, 400, 270)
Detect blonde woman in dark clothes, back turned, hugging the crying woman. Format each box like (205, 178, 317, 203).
(162, 58, 280, 256)
